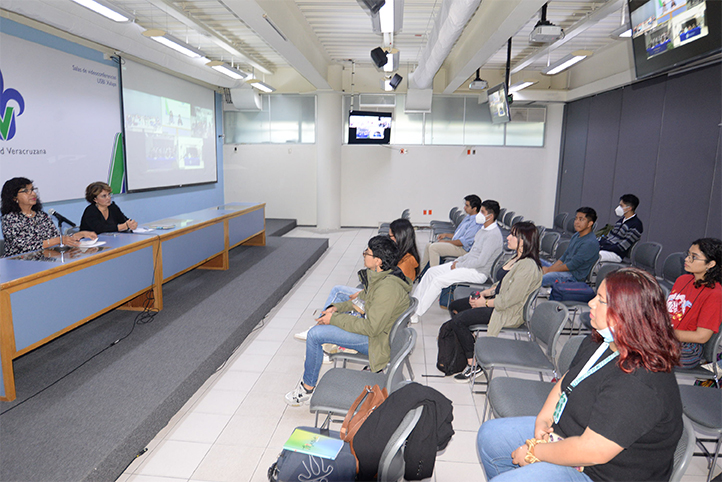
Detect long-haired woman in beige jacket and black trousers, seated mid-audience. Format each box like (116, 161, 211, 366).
(449, 221, 542, 382)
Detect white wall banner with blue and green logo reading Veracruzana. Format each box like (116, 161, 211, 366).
(0, 33, 121, 202)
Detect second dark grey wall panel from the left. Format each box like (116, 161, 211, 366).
(581, 89, 622, 225)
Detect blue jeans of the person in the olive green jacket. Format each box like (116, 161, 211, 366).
(303, 325, 369, 387)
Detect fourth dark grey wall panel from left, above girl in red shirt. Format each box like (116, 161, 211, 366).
(647, 65, 722, 268)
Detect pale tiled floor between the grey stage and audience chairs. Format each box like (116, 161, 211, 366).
(118, 228, 720, 482)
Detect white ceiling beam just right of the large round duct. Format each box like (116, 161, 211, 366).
(444, 0, 549, 94)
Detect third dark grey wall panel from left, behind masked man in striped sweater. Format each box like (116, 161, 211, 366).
(612, 77, 666, 235)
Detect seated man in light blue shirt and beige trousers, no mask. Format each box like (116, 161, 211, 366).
(420, 194, 481, 274)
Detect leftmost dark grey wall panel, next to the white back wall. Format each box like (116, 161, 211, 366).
(556, 99, 590, 213)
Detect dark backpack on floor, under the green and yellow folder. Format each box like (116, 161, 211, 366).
(268, 427, 356, 482)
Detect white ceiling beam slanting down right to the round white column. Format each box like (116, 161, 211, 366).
(223, 0, 331, 90)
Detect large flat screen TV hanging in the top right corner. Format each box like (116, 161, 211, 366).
(628, 0, 722, 79)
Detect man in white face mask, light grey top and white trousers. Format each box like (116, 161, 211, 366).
(411, 199, 503, 323)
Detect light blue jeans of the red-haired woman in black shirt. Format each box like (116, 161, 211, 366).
(476, 417, 592, 482)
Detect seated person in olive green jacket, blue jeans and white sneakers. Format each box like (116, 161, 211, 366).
(285, 236, 411, 407)
